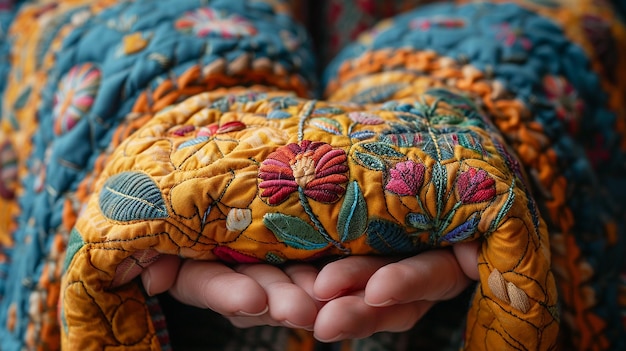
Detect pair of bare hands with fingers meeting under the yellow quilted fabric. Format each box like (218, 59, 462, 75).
(141, 242, 479, 342)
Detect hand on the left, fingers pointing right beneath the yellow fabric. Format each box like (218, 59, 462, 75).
(141, 255, 321, 330)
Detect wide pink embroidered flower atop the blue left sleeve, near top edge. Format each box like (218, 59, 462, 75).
(175, 7, 257, 38)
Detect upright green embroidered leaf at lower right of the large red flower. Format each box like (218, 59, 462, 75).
(337, 182, 367, 242)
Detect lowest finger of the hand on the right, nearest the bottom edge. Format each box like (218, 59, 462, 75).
(314, 295, 435, 342)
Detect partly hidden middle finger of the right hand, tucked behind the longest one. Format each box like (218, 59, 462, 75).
(313, 256, 393, 301)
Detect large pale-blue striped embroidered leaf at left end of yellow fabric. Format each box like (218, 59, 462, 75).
(99, 172, 168, 222)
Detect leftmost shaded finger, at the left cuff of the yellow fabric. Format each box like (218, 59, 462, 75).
(141, 255, 180, 296)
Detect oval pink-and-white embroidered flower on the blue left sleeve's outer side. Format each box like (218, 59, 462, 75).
(53, 63, 101, 135)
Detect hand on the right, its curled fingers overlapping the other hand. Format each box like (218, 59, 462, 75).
(313, 242, 479, 342)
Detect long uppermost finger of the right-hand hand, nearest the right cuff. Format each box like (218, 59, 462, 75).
(365, 249, 470, 307)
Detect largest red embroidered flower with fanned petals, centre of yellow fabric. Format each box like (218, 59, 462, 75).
(259, 140, 348, 205)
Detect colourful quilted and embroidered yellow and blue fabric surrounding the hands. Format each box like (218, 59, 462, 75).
(0, 0, 626, 351)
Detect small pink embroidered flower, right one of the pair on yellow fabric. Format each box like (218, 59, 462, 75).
(456, 168, 496, 204)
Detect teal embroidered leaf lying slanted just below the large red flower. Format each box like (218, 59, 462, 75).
(263, 213, 328, 250)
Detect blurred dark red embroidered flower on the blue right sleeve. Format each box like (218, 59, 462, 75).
(543, 76, 585, 134)
